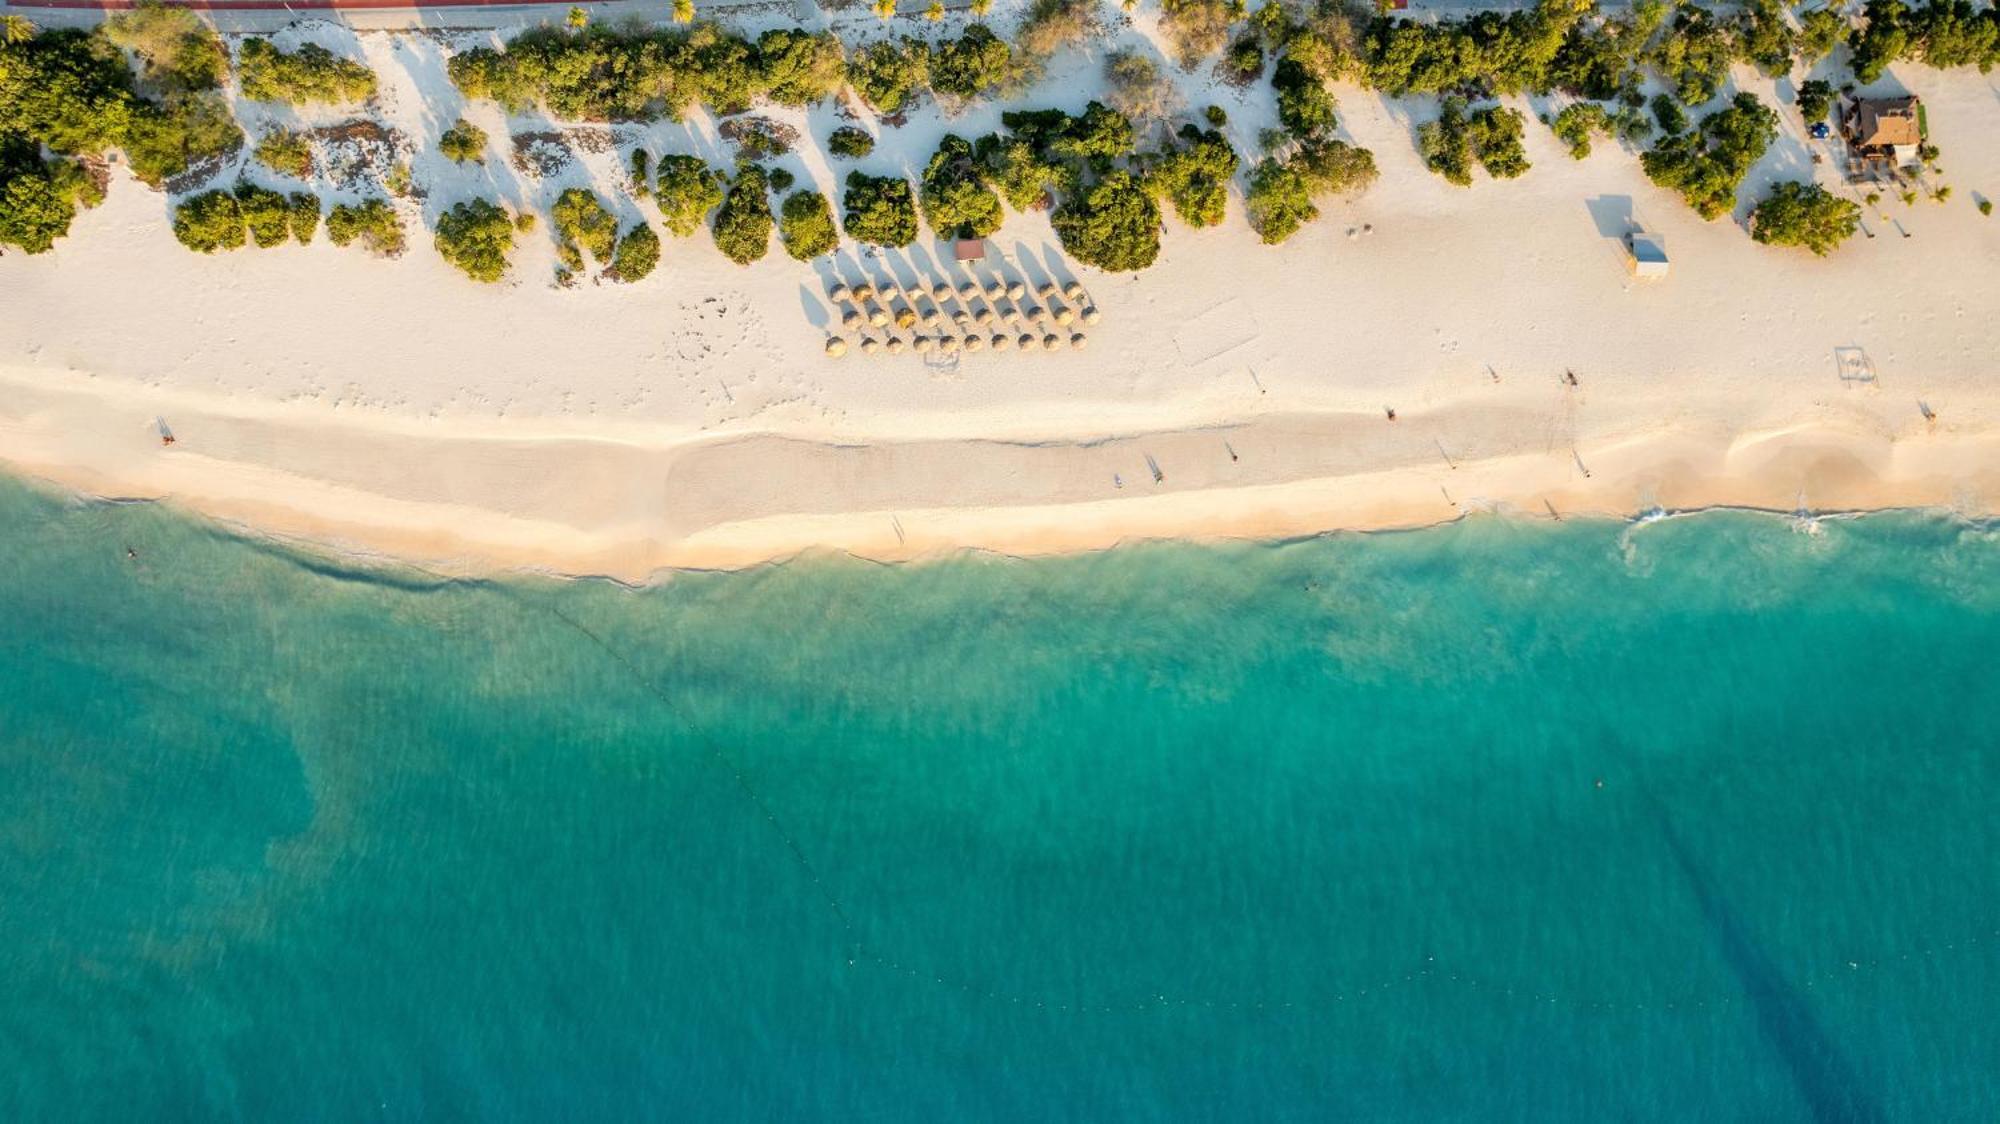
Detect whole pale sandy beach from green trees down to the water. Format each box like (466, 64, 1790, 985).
(0, 14, 2000, 578)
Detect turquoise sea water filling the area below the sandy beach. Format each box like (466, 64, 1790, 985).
(0, 476, 2000, 1122)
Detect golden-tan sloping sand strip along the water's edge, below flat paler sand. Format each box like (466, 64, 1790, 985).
(0, 366, 2000, 584)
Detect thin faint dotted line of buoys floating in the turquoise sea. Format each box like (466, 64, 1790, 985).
(534, 588, 2000, 1014)
